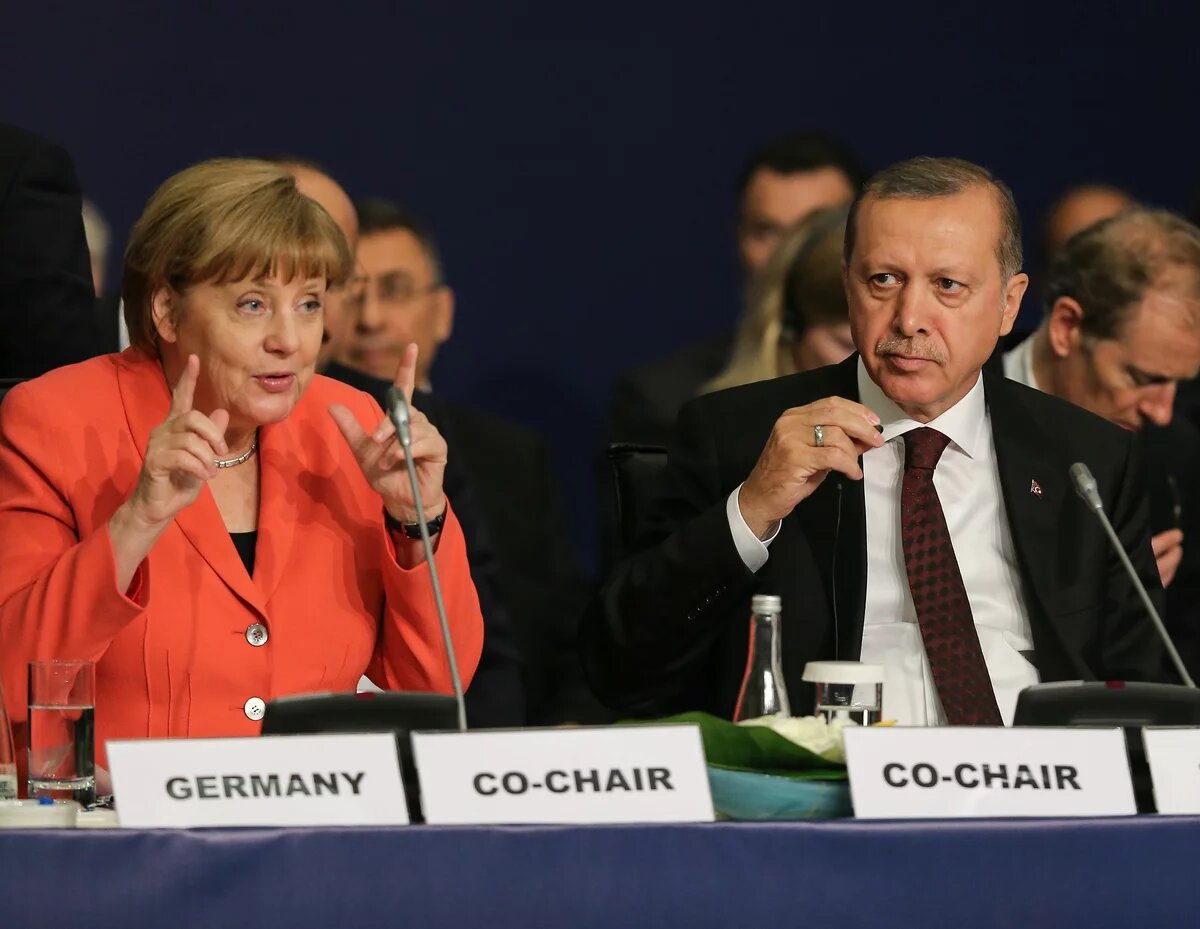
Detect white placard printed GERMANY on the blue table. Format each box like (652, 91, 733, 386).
(108, 732, 408, 828)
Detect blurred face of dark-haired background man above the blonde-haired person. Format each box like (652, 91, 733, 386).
(738, 168, 854, 275)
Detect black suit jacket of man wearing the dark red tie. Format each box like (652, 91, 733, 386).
(582, 355, 1163, 717)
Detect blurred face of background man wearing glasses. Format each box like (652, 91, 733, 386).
(338, 229, 454, 386)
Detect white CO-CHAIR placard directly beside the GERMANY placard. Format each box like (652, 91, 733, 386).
(413, 725, 713, 823)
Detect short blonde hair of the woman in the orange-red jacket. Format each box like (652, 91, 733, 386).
(121, 158, 354, 353)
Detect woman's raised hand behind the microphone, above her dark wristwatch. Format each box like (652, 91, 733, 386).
(329, 342, 446, 523)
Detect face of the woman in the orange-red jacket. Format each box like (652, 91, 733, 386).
(152, 276, 325, 430)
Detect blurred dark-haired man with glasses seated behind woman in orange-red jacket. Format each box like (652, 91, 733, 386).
(324, 199, 607, 725)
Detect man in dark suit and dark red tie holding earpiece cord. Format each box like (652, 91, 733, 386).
(583, 158, 1163, 725)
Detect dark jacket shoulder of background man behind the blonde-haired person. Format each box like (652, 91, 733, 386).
(608, 332, 733, 445)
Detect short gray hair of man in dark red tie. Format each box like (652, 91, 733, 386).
(842, 155, 1022, 282)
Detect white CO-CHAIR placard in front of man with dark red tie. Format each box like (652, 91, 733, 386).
(844, 726, 1136, 819)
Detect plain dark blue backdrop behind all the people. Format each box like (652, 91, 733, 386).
(0, 0, 1200, 571)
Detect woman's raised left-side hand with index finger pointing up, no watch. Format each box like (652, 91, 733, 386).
(126, 355, 229, 528)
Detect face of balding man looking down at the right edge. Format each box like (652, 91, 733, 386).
(1051, 289, 1200, 431)
